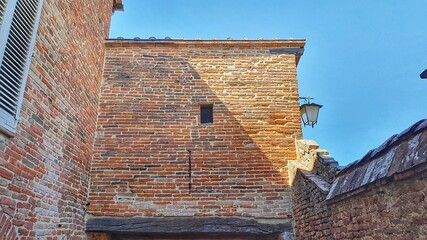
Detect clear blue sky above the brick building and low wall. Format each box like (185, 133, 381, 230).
(110, 0, 427, 165)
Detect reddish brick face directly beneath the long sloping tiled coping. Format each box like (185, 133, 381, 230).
(330, 166, 427, 239)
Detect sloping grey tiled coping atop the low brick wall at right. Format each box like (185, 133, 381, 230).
(327, 119, 427, 199)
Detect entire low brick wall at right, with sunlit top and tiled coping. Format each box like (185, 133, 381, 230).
(293, 120, 427, 239)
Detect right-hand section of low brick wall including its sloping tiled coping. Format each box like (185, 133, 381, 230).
(327, 119, 427, 239)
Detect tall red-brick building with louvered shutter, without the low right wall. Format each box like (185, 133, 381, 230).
(0, 0, 304, 239)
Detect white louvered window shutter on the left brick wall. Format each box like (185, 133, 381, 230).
(0, 0, 42, 134)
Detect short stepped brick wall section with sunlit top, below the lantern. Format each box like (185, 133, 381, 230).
(289, 140, 338, 239)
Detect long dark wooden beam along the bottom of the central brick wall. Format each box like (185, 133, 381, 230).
(86, 217, 292, 235)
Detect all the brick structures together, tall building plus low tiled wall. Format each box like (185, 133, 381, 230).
(0, 0, 427, 239)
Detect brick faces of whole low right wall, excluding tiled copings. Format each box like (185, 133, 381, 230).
(293, 166, 427, 239)
